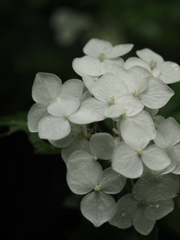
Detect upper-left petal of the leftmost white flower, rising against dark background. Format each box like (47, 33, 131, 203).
(32, 73, 62, 104)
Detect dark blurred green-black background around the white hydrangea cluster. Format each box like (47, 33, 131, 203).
(0, 0, 180, 240)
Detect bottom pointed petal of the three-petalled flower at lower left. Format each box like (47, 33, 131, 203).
(81, 191, 115, 227)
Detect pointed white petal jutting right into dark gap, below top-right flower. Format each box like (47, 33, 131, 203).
(141, 78, 174, 109)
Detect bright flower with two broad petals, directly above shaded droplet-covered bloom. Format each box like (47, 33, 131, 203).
(112, 141, 171, 178)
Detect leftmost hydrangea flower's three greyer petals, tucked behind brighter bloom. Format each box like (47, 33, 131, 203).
(28, 73, 84, 132)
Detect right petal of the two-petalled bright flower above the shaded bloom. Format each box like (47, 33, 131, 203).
(141, 144, 171, 171)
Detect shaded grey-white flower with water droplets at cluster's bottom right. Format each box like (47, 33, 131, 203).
(109, 180, 174, 235)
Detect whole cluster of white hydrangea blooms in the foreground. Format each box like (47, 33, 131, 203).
(28, 39, 180, 235)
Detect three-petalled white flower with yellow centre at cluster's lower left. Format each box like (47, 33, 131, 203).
(67, 154, 126, 227)
